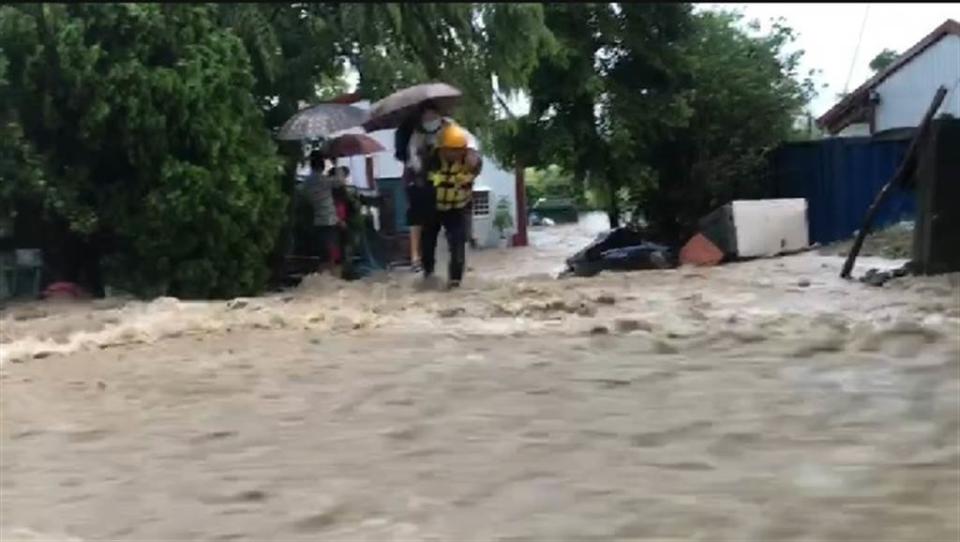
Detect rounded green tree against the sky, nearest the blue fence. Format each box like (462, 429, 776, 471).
(634, 11, 813, 242)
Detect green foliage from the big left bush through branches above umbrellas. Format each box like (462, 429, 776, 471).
(0, 3, 553, 296)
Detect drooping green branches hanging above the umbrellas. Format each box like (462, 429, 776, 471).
(217, 3, 552, 147)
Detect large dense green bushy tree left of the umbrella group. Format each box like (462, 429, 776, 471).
(0, 4, 284, 297)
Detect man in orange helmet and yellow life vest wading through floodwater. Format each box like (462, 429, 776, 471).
(422, 123, 481, 288)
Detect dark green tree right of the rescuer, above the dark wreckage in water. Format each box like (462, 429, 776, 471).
(498, 4, 691, 225)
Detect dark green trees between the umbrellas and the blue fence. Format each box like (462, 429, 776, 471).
(496, 4, 813, 240)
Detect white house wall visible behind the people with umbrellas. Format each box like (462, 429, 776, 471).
(330, 101, 517, 246)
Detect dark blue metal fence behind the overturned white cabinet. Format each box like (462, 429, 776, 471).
(772, 137, 915, 244)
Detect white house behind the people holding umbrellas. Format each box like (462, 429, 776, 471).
(318, 97, 524, 247)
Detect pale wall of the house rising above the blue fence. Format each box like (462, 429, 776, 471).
(874, 34, 960, 132)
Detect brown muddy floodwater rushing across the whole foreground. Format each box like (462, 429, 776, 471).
(0, 219, 960, 542)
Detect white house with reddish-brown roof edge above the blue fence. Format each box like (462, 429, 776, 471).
(817, 19, 960, 136)
